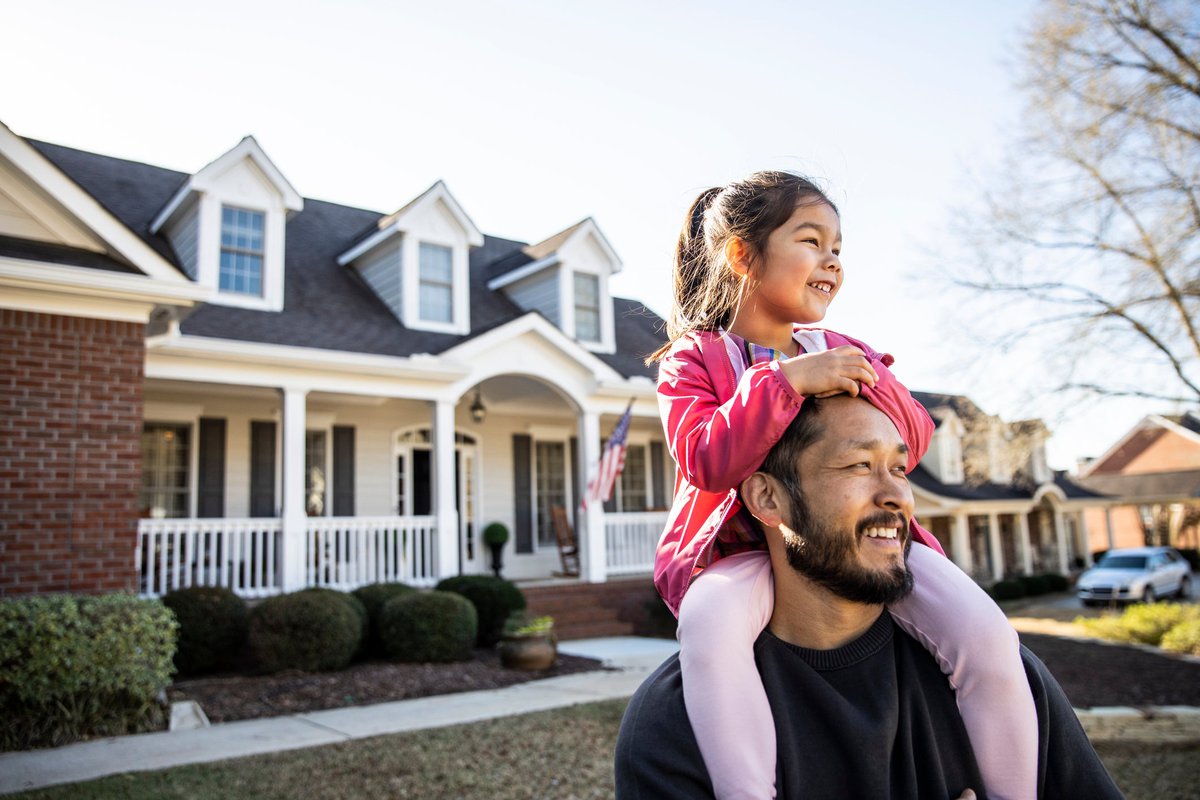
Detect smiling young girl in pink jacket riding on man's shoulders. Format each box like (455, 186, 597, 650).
(650, 172, 1037, 800)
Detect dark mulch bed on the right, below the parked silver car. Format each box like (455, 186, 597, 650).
(1021, 633, 1200, 709)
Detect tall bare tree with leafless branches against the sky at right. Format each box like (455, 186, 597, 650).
(953, 0, 1200, 403)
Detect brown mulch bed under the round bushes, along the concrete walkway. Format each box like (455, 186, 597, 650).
(167, 648, 601, 722)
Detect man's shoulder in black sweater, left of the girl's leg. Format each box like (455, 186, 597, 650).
(614, 654, 713, 800)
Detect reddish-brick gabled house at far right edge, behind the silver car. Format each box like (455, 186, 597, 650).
(1079, 411, 1200, 551)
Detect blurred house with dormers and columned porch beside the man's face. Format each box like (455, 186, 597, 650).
(910, 392, 1104, 583)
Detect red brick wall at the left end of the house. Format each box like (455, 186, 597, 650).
(0, 309, 145, 596)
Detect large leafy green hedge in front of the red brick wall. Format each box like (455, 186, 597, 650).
(0, 595, 178, 750)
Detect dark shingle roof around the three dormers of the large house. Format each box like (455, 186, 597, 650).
(30, 142, 662, 378)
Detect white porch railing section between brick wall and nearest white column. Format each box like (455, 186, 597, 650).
(136, 517, 283, 597)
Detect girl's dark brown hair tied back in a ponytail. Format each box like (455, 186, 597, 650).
(646, 170, 838, 363)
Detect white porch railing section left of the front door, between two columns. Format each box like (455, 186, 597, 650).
(305, 517, 438, 590)
